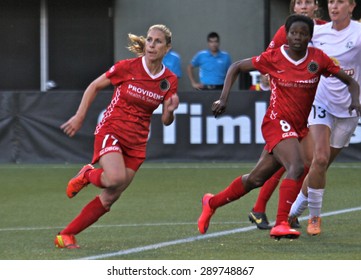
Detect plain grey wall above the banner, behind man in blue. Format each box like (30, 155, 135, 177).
(114, 0, 289, 91)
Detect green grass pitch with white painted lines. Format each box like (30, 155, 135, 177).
(0, 163, 361, 260)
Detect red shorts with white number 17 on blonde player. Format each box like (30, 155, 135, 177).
(92, 134, 145, 171)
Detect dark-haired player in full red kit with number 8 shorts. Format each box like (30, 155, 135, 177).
(198, 15, 360, 238)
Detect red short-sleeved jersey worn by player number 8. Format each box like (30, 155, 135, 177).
(252, 45, 340, 141)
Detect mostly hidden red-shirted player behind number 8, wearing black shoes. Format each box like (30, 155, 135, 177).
(248, 0, 327, 229)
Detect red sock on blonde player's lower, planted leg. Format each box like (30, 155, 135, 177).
(60, 196, 109, 234)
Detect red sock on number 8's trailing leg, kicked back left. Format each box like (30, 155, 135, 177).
(209, 176, 247, 209)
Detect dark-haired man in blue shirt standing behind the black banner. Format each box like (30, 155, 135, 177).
(187, 32, 232, 90)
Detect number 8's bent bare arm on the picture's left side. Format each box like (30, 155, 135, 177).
(212, 58, 255, 117)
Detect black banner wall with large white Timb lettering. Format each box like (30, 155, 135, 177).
(0, 91, 361, 163)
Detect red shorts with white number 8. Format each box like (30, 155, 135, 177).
(262, 117, 308, 153)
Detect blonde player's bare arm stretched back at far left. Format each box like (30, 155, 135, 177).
(60, 74, 111, 137)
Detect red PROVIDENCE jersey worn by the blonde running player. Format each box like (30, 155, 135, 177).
(94, 57, 178, 157)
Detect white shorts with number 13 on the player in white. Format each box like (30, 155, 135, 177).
(308, 105, 359, 149)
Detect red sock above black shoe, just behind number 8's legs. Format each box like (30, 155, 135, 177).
(253, 167, 286, 213)
